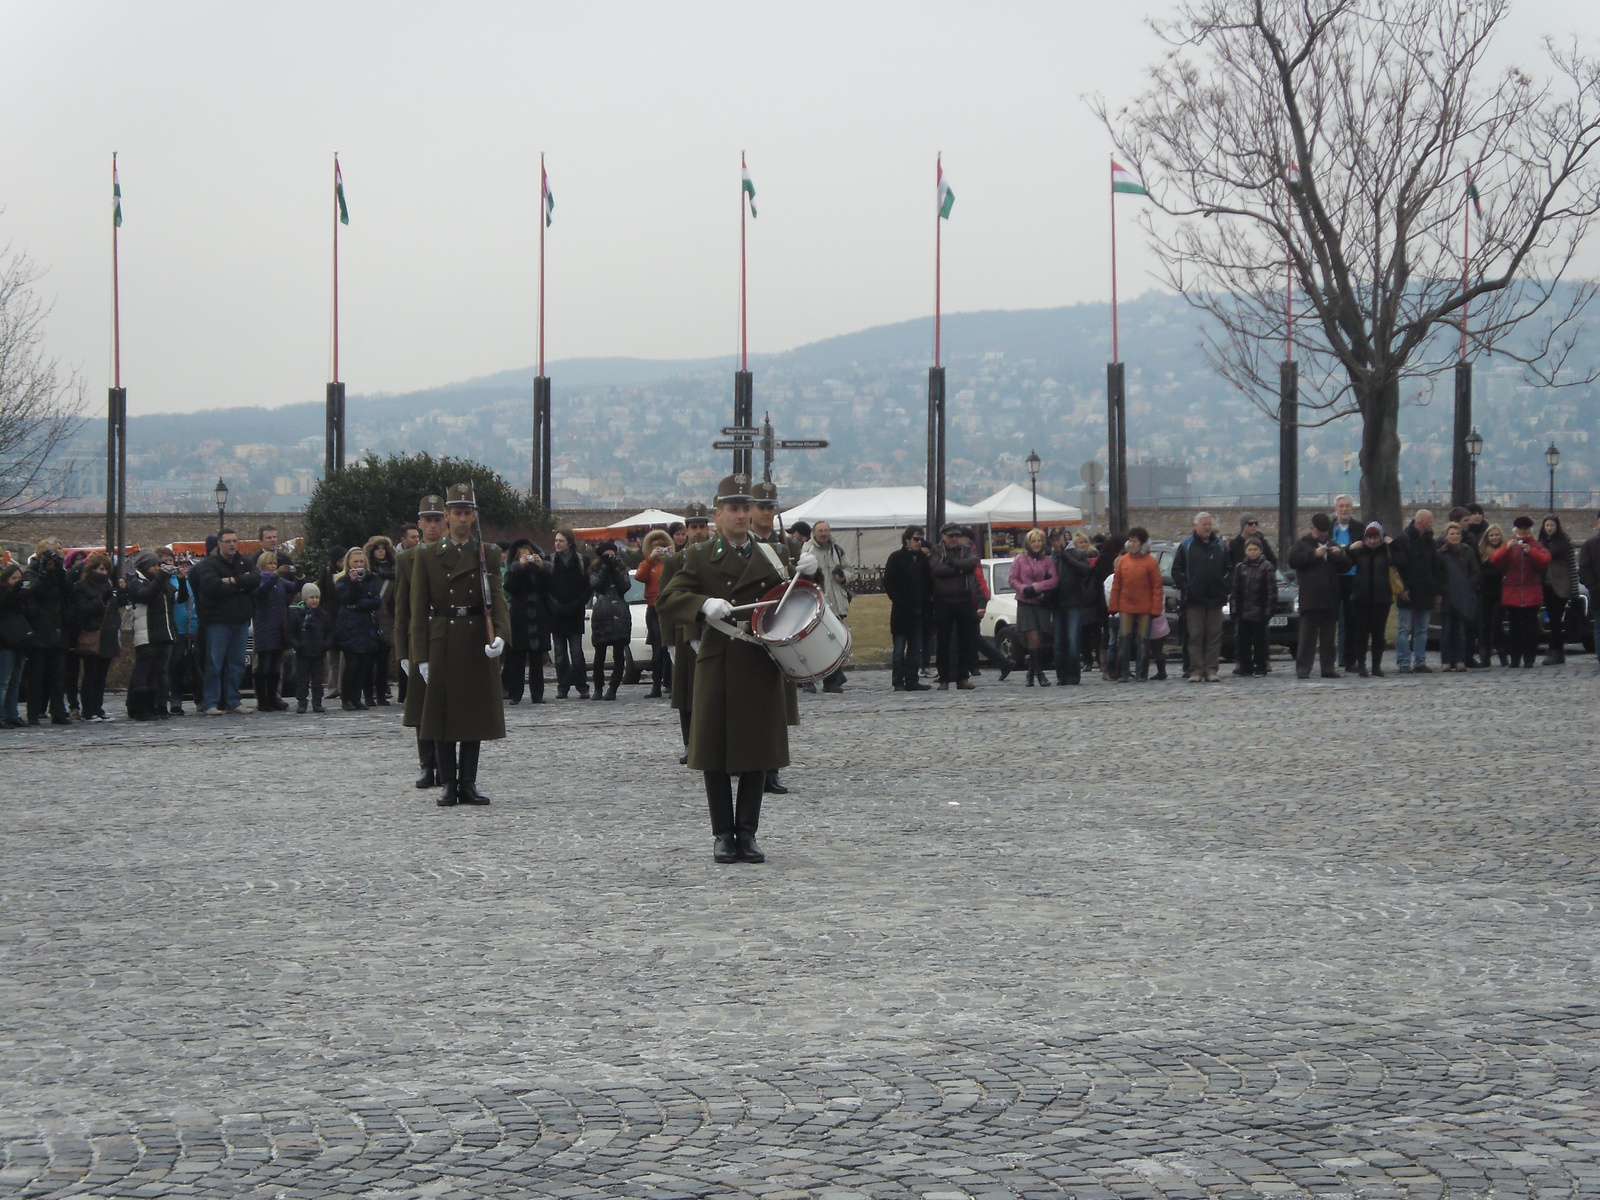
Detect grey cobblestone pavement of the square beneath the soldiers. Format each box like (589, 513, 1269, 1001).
(0, 661, 1600, 1200)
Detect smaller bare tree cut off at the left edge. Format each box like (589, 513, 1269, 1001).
(0, 248, 85, 528)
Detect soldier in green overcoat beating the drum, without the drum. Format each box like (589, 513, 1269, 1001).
(656, 474, 816, 862)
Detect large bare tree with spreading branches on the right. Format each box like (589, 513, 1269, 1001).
(1096, 0, 1600, 526)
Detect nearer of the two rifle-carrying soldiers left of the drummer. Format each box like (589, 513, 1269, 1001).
(410, 483, 510, 808)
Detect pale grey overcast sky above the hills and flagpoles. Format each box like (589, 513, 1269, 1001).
(0, 0, 1600, 413)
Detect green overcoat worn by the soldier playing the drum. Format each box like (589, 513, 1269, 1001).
(656, 538, 789, 774)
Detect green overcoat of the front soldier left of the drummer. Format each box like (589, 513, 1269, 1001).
(406, 538, 510, 742)
